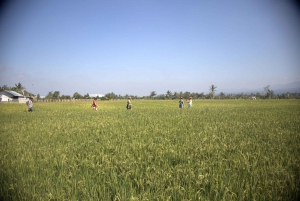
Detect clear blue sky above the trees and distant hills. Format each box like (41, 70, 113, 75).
(0, 0, 300, 96)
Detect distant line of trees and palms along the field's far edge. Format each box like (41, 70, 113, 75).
(0, 83, 300, 100)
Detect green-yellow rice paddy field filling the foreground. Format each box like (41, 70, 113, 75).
(0, 100, 300, 201)
